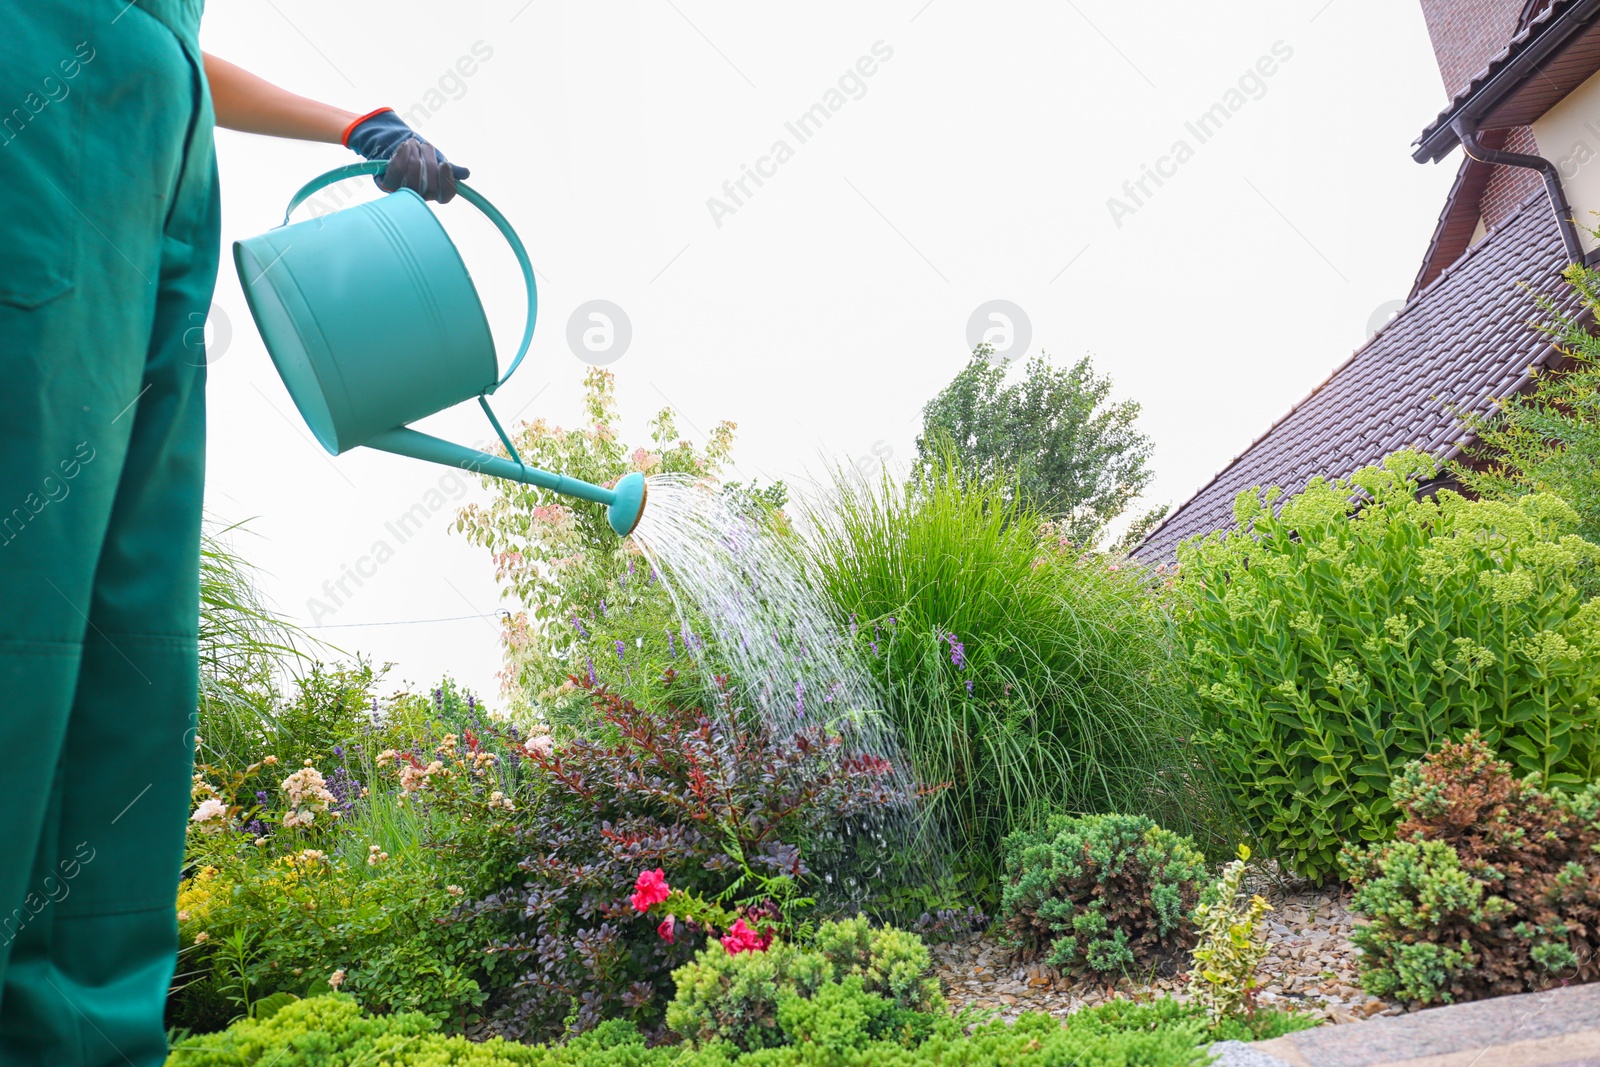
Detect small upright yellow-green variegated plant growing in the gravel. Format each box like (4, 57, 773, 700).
(1189, 845, 1272, 1019)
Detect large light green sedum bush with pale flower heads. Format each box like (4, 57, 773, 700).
(1176, 453, 1600, 880)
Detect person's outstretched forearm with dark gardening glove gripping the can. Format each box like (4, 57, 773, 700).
(205, 53, 472, 203)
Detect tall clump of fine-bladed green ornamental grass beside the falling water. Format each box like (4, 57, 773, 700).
(805, 464, 1205, 889)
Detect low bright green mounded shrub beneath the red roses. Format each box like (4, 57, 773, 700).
(667, 917, 944, 1051)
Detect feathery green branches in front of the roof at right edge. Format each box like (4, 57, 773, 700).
(1453, 259, 1600, 541)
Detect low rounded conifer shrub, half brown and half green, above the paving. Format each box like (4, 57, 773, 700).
(1344, 734, 1600, 1003)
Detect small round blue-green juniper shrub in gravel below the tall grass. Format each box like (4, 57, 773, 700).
(1000, 814, 1205, 973)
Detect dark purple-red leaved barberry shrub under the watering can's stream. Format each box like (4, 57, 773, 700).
(474, 678, 915, 1040)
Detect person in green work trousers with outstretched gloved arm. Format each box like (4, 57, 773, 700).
(0, 0, 466, 1067)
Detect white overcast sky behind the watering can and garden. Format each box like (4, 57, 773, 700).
(202, 0, 1458, 713)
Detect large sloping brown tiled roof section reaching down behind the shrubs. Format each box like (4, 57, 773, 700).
(1133, 192, 1576, 563)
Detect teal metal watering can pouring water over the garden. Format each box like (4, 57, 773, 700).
(234, 162, 645, 537)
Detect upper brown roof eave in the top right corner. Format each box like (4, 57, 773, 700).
(1414, 0, 1600, 162)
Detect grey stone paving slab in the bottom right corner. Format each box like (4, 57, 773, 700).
(1216, 982, 1600, 1067)
